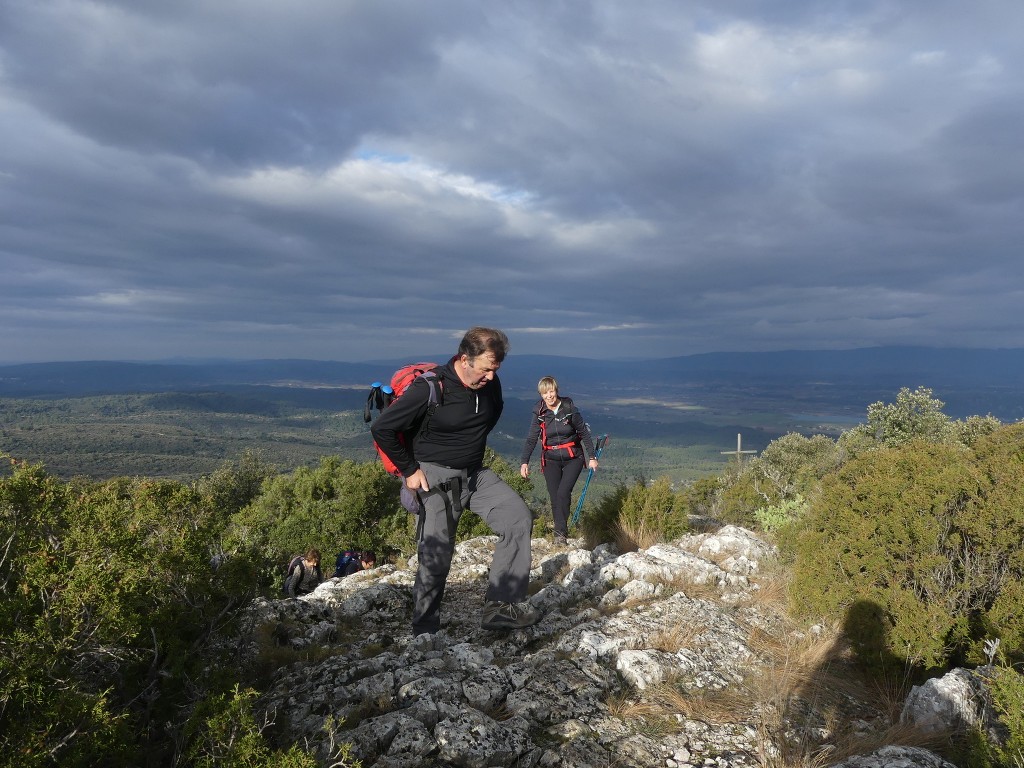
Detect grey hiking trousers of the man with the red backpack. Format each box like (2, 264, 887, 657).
(413, 462, 534, 635)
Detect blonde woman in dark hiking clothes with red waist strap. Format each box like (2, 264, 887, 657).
(519, 376, 597, 546)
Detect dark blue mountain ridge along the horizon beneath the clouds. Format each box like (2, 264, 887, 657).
(0, 347, 1024, 397)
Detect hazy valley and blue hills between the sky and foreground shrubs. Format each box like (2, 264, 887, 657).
(0, 347, 1024, 481)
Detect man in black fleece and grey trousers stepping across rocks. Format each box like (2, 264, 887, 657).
(370, 328, 540, 635)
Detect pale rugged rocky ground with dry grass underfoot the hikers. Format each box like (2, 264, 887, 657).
(232, 526, 974, 768)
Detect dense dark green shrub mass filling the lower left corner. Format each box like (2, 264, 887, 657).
(0, 462, 264, 766)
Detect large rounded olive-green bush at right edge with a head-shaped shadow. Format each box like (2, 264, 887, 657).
(782, 425, 1024, 670)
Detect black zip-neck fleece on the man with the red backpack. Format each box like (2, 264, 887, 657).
(370, 357, 505, 477)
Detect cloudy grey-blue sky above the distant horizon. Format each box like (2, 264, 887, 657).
(0, 0, 1024, 364)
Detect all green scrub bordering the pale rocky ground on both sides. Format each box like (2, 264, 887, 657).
(0, 388, 1024, 768)
